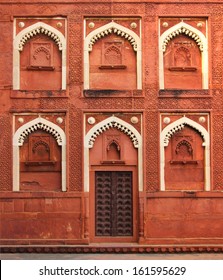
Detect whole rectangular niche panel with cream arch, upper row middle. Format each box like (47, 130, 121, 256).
(84, 18, 142, 90)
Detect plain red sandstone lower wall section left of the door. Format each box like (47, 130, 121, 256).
(1, 193, 83, 244)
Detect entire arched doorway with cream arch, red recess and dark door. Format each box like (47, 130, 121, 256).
(85, 117, 142, 242)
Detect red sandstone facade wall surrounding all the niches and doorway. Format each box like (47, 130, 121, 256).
(0, 0, 223, 244)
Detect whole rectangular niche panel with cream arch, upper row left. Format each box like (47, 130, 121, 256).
(13, 18, 67, 90)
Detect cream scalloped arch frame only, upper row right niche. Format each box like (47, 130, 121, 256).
(159, 21, 208, 89)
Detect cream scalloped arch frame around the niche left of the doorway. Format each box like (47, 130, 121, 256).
(13, 117, 66, 191)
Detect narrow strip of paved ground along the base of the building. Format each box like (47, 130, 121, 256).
(0, 253, 223, 260)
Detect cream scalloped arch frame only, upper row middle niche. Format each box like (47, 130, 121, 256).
(84, 22, 142, 89)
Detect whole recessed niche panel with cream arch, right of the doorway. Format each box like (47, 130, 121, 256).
(160, 113, 210, 191)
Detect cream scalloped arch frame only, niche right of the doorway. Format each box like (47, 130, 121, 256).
(160, 117, 210, 191)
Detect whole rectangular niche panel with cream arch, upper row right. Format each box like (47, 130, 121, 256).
(159, 18, 208, 89)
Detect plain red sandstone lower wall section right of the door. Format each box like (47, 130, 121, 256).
(146, 195, 223, 244)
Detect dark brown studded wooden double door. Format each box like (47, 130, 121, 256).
(95, 171, 133, 237)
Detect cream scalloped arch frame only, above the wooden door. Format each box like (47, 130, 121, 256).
(84, 116, 143, 192)
